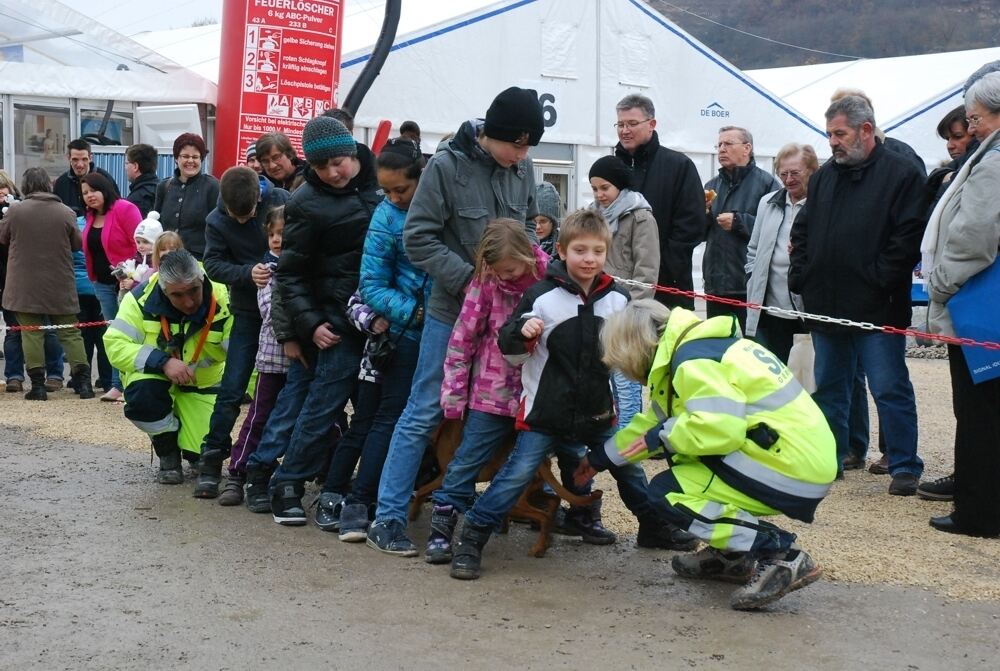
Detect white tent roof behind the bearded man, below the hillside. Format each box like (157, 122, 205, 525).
(747, 47, 1000, 168)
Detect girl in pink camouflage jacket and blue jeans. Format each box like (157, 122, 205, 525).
(425, 219, 549, 564)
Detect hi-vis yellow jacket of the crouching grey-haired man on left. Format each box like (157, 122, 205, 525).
(104, 273, 233, 391)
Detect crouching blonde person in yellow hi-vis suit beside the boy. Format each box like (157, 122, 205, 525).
(577, 300, 837, 610)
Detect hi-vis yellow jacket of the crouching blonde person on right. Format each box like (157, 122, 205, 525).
(590, 308, 837, 522)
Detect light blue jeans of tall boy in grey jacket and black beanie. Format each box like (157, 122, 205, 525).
(375, 316, 453, 524)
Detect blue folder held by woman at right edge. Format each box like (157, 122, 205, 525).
(948, 260, 1000, 384)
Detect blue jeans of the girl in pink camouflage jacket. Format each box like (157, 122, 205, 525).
(432, 410, 514, 513)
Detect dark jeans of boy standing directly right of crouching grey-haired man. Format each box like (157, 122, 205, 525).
(201, 312, 260, 475)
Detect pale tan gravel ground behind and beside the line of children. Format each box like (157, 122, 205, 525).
(0, 357, 1000, 601)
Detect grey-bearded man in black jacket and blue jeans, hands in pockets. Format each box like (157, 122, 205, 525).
(788, 96, 926, 496)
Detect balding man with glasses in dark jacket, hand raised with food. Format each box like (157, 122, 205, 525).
(702, 126, 781, 332)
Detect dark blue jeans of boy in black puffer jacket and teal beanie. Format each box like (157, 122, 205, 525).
(271, 332, 364, 491)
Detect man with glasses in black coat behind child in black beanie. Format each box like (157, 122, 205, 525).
(615, 94, 705, 310)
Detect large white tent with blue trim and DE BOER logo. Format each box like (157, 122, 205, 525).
(136, 0, 824, 207)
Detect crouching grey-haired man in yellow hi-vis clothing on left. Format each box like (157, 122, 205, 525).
(104, 250, 233, 485)
